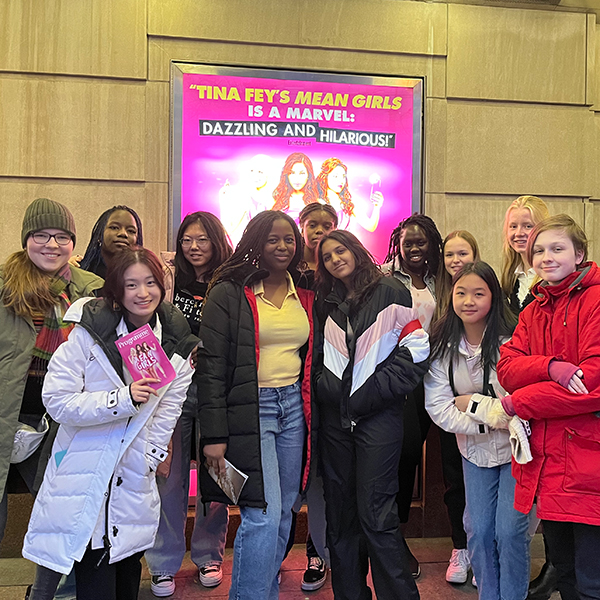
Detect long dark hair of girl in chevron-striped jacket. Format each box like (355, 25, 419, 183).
(315, 229, 383, 308)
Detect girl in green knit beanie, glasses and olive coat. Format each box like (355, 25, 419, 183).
(0, 198, 103, 541)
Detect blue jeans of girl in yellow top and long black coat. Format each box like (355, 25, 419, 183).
(229, 382, 306, 600)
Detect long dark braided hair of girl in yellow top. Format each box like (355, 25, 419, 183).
(208, 210, 304, 291)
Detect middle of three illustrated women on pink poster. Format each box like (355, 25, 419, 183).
(273, 152, 319, 222)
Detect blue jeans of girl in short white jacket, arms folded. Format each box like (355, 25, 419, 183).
(463, 457, 531, 600)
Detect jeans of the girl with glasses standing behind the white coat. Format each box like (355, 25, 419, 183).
(145, 383, 228, 575)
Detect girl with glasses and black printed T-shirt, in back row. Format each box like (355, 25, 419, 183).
(146, 211, 232, 597)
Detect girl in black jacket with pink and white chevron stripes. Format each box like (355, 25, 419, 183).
(315, 230, 429, 600)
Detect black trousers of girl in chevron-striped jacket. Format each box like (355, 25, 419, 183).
(319, 407, 419, 600)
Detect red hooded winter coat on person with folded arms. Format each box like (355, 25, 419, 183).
(498, 262, 600, 525)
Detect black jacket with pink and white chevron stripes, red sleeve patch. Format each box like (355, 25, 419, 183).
(316, 277, 429, 428)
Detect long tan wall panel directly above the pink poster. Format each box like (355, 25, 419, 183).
(148, 0, 447, 55)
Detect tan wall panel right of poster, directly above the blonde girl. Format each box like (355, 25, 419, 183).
(446, 101, 598, 197)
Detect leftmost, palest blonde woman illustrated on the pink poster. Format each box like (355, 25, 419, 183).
(219, 154, 274, 246)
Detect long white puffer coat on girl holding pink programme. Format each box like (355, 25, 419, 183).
(23, 299, 198, 574)
